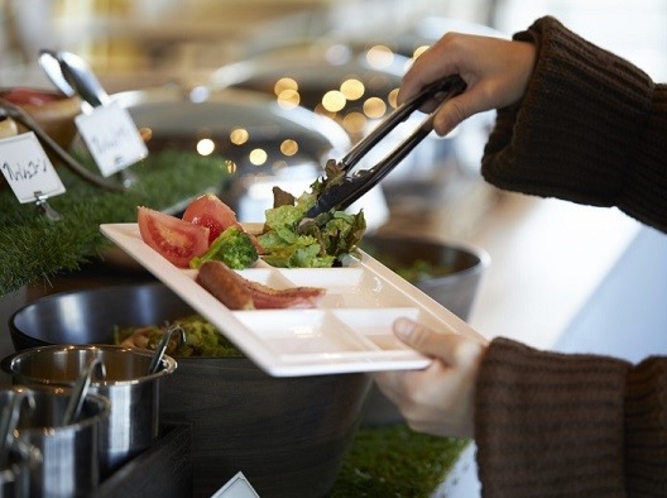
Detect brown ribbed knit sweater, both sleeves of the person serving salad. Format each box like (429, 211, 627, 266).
(475, 17, 667, 498)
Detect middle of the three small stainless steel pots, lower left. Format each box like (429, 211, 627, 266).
(0, 387, 111, 497)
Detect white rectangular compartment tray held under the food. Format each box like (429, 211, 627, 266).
(100, 223, 481, 377)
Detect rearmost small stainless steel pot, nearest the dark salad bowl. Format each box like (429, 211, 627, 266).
(2, 345, 176, 478)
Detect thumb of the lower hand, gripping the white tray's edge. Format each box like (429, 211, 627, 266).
(393, 318, 482, 366)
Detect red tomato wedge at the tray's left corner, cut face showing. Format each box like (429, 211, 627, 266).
(137, 206, 209, 268)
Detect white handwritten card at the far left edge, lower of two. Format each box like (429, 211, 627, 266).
(0, 132, 65, 204)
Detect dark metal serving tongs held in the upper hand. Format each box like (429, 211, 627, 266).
(306, 75, 466, 218)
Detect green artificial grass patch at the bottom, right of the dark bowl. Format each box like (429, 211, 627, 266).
(329, 424, 469, 498)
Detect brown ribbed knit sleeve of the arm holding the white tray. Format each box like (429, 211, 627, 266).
(475, 339, 667, 497)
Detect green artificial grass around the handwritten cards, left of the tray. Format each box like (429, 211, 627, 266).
(0, 150, 228, 296)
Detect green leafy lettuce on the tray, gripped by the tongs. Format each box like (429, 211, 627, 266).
(257, 160, 366, 268)
